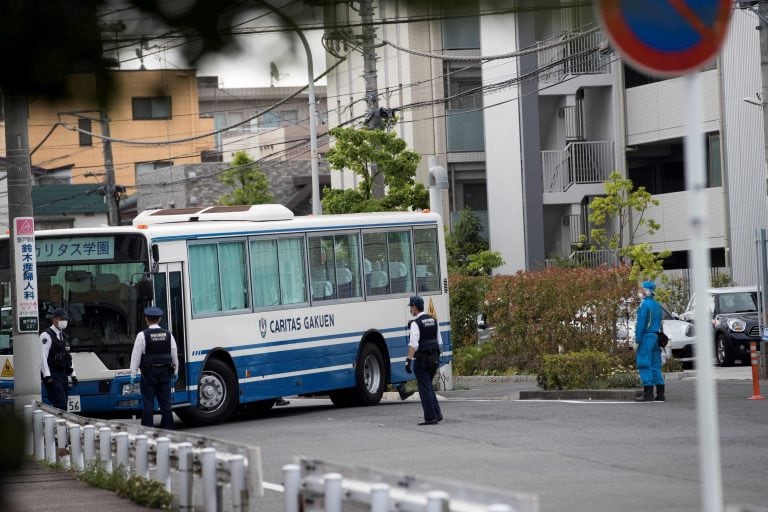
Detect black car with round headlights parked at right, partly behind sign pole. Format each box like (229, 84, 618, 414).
(680, 286, 760, 366)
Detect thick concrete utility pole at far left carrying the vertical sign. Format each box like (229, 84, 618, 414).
(3, 91, 41, 408)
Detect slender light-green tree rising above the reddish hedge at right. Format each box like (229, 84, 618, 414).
(589, 171, 671, 280)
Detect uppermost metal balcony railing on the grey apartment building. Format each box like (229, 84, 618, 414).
(538, 28, 610, 83)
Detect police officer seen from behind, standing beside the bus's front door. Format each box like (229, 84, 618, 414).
(131, 306, 179, 429)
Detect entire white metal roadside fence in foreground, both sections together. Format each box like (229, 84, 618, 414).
(24, 403, 539, 512)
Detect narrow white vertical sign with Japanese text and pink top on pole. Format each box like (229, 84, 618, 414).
(13, 217, 38, 332)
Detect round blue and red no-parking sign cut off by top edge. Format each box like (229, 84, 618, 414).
(597, 0, 733, 77)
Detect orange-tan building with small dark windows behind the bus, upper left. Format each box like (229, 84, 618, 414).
(11, 69, 215, 200)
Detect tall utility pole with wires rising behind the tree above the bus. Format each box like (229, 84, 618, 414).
(360, 0, 384, 198)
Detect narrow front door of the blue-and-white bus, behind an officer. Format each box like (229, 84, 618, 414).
(155, 262, 189, 405)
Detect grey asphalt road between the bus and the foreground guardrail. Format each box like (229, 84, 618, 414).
(184, 368, 768, 512)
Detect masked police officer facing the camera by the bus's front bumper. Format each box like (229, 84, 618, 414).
(40, 308, 77, 411)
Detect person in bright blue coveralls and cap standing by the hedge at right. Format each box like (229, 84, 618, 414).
(635, 281, 665, 402)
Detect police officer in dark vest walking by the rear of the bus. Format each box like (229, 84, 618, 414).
(405, 295, 443, 425)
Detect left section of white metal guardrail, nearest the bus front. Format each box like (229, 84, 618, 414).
(24, 403, 264, 512)
